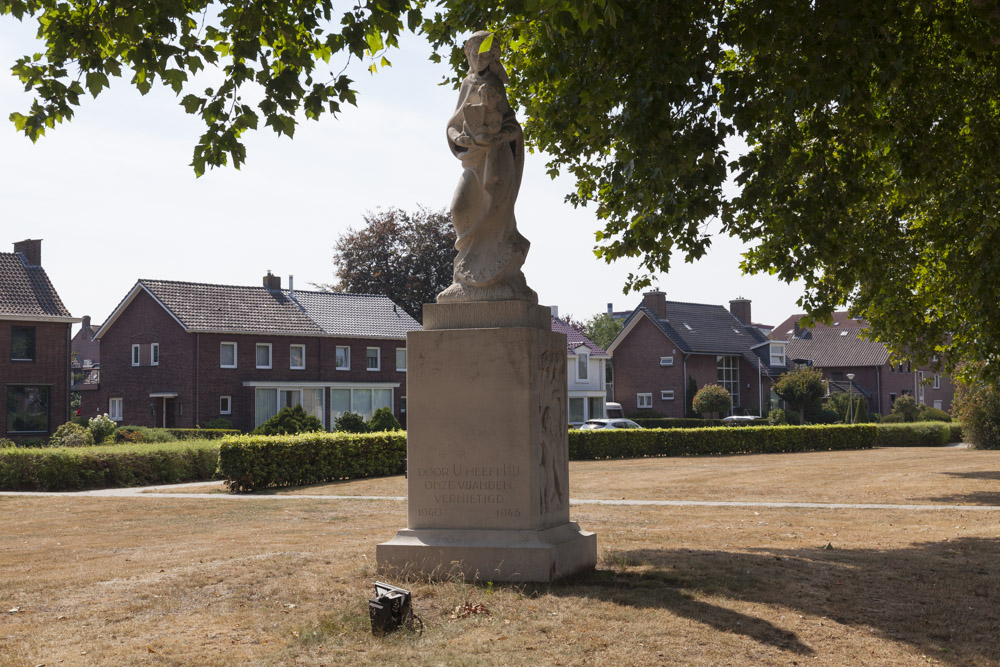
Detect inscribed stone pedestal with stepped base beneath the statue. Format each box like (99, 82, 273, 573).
(376, 302, 597, 582)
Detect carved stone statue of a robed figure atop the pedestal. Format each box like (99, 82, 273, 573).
(437, 32, 538, 304)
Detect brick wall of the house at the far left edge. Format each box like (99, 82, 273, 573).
(0, 320, 71, 440)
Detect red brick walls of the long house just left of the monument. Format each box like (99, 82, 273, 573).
(82, 292, 406, 431)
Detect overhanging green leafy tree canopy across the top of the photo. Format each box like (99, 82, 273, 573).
(7, 0, 1000, 380)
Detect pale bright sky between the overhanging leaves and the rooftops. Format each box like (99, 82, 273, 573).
(0, 17, 802, 334)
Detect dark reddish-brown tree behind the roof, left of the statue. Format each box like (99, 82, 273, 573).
(317, 208, 456, 322)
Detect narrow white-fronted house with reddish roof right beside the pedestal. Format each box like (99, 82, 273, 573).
(552, 314, 611, 426)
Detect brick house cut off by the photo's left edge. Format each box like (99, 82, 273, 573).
(0, 239, 80, 440)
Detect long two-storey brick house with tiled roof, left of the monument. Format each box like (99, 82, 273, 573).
(83, 273, 420, 431)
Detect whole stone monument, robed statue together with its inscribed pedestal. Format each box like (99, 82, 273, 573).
(376, 32, 597, 582)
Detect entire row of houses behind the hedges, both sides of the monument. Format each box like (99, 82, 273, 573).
(0, 240, 952, 439)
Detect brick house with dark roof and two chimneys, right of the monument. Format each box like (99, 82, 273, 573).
(608, 290, 787, 418)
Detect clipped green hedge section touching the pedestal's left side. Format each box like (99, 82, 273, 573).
(219, 431, 406, 493)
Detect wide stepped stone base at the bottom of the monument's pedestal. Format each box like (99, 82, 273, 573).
(375, 522, 597, 582)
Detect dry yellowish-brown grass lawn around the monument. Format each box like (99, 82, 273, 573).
(0, 449, 1000, 666)
